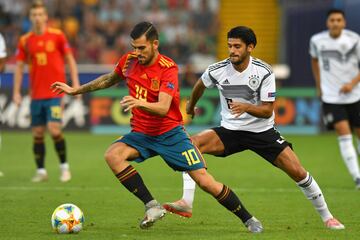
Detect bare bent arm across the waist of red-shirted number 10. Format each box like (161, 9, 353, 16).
(120, 92, 173, 117)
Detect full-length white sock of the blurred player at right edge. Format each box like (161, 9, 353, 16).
(338, 134, 360, 180)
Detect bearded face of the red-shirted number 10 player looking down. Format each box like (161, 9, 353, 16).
(131, 35, 159, 65)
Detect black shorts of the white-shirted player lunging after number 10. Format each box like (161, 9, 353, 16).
(212, 127, 292, 165)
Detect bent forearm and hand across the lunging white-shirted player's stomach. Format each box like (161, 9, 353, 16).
(229, 102, 274, 118)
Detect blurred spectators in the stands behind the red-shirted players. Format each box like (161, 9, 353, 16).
(0, 0, 219, 85)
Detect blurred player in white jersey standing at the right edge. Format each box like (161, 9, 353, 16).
(310, 9, 360, 190)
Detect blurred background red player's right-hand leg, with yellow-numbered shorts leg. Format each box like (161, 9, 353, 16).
(46, 98, 71, 182)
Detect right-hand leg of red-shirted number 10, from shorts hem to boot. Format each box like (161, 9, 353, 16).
(189, 168, 263, 233)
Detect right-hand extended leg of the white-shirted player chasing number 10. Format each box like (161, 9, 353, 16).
(274, 146, 345, 229)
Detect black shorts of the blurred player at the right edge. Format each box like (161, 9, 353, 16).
(322, 101, 360, 129)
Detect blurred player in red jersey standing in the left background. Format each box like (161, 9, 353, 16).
(13, 2, 80, 182)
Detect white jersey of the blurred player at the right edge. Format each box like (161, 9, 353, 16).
(310, 29, 360, 104)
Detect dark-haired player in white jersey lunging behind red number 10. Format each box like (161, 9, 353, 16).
(164, 26, 345, 229)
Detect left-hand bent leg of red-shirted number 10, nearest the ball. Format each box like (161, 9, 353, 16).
(105, 142, 166, 228)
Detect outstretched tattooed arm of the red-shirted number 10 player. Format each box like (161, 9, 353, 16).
(51, 72, 121, 95)
